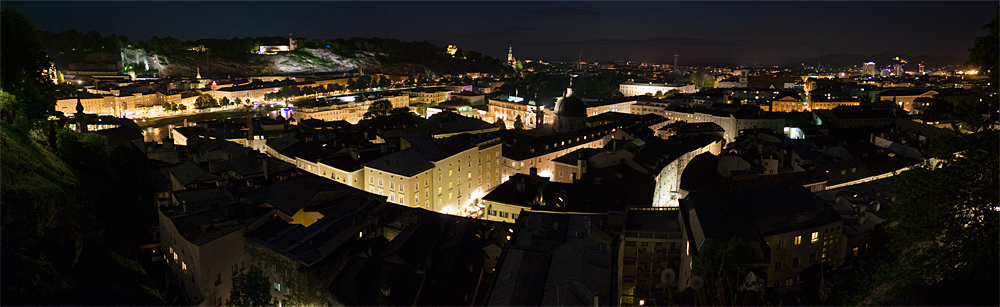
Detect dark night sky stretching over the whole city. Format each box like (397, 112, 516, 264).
(0, 1, 998, 64)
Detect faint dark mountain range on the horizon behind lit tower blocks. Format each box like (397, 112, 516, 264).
(786, 51, 966, 69)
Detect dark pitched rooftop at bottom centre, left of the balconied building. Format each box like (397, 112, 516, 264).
(485, 212, 620, 306)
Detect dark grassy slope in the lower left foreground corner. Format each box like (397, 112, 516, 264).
(0, 126, 163, 305)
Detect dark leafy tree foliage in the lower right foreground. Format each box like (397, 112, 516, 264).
(890, 130, 1000, 303)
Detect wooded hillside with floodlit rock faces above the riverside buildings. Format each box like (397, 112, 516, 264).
(39, 30, 508, 77)
